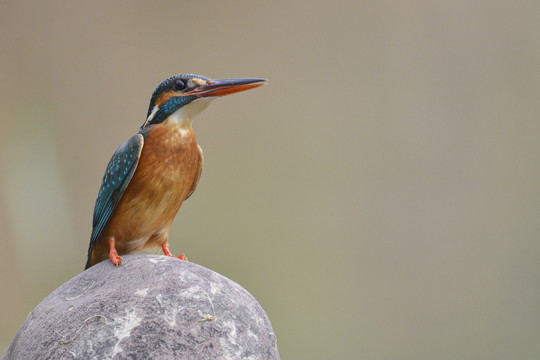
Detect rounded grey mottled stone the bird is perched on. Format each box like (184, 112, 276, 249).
(2, 255, 279, 360)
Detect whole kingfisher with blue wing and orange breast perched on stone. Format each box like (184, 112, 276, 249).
(85, 74, 267, 270)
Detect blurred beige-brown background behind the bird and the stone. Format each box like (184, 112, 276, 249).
(0, 0, 540, 360)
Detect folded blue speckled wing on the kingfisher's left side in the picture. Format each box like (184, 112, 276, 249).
(86, 134, 144, 269)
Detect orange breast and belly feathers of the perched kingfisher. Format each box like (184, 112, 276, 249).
(100, 125, 199, 254)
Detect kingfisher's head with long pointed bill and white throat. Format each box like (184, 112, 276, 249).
(141, 74, 266, 129)
